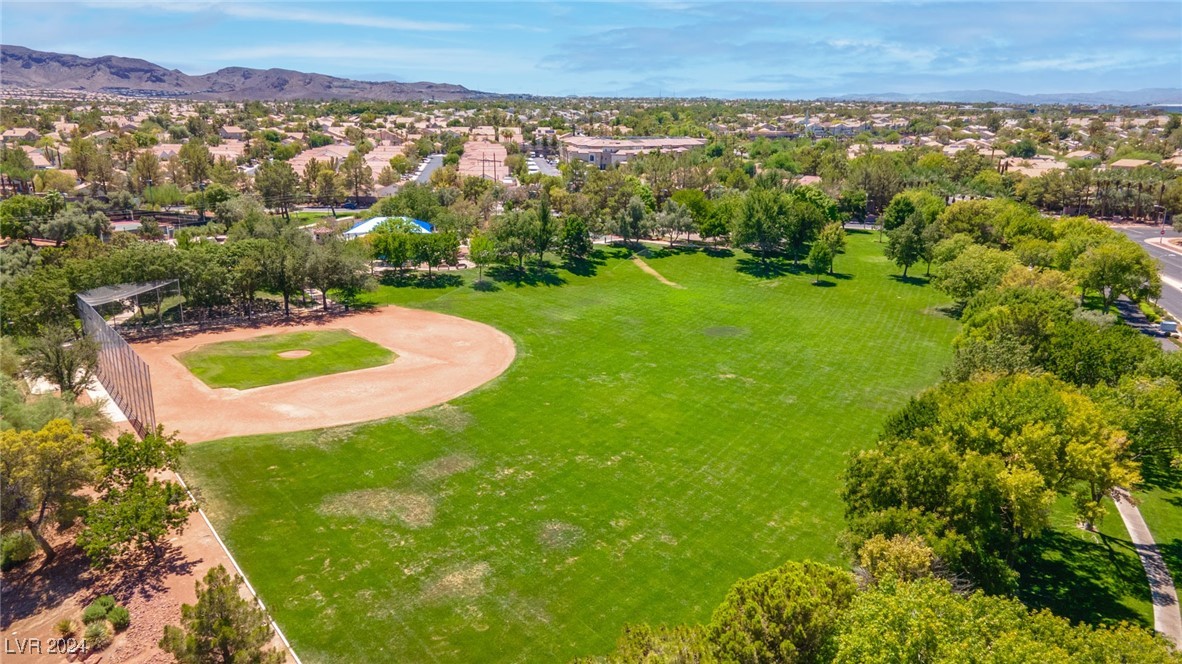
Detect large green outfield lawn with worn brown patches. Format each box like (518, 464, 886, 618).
(179, 234, 973, 663)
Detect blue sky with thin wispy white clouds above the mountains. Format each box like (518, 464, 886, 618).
(0, 0, 1182, 98)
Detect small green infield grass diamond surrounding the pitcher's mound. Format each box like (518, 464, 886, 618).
(176, 330, 397, 390)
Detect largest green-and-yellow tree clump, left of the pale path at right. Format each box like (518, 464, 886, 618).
(843, 375, 1138, 592)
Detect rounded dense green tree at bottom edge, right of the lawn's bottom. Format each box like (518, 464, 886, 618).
(707, 561, 857, 664)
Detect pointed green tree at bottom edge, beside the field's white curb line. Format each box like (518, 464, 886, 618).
(160, 565, 286, 664)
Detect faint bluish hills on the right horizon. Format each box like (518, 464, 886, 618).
(826, 87, 1182, 106)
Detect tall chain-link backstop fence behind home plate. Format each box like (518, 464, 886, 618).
(77, 280, 176, 436)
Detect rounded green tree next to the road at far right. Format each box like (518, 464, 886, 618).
(1071, 237, 1162, 312)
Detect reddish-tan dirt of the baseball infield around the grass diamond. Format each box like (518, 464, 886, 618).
(132, 307, 517, 443)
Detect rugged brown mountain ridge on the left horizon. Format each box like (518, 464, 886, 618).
(0, 46, 491, 102)
